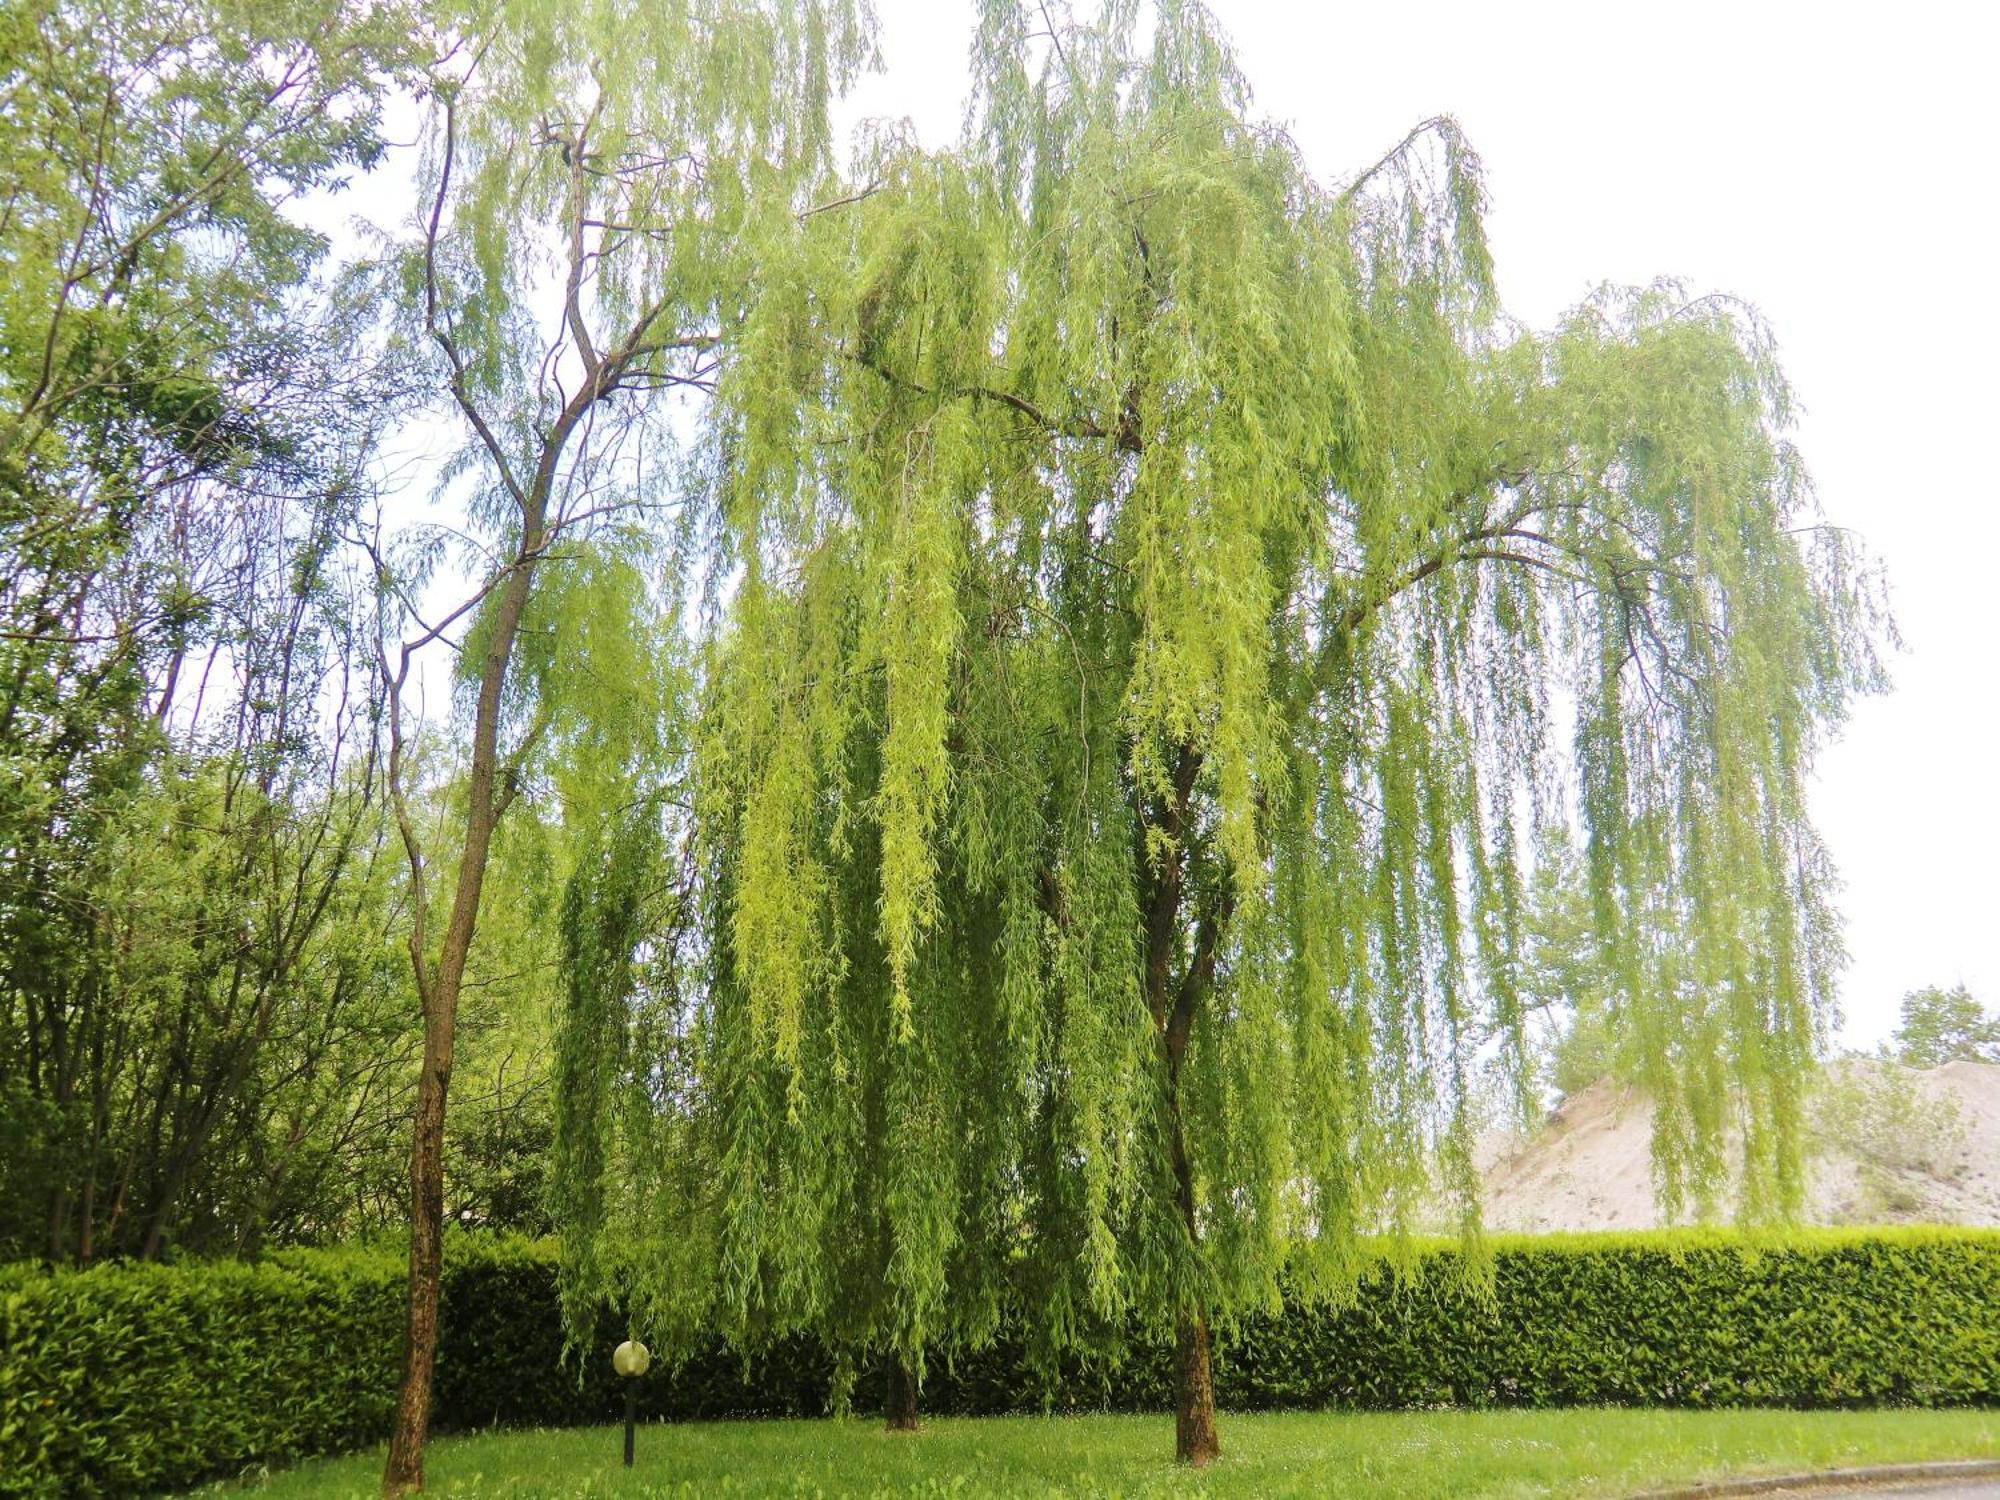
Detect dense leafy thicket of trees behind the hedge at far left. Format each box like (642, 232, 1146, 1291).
(0, 0, 408, 1260)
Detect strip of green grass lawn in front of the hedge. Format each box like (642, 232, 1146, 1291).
(204, 1410, 2000, 1500)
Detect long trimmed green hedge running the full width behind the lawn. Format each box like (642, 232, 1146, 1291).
(0, 1230, 2000, 1496)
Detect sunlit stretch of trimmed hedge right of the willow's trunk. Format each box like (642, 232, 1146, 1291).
(1220, 1230, 2000, 1408)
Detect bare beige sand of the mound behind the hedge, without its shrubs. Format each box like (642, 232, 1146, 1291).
(1480, 1062, 2000, 1230)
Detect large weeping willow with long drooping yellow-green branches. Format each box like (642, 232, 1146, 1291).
(552, 0, 1880, 1462)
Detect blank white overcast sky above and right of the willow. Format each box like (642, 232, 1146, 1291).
(832, 0, 2000, 1046)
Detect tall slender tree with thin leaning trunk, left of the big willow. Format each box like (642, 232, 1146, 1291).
(382, 0, 866, 1494)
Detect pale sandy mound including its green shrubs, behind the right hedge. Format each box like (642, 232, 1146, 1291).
(1480, 1062, 2000, 1230)
